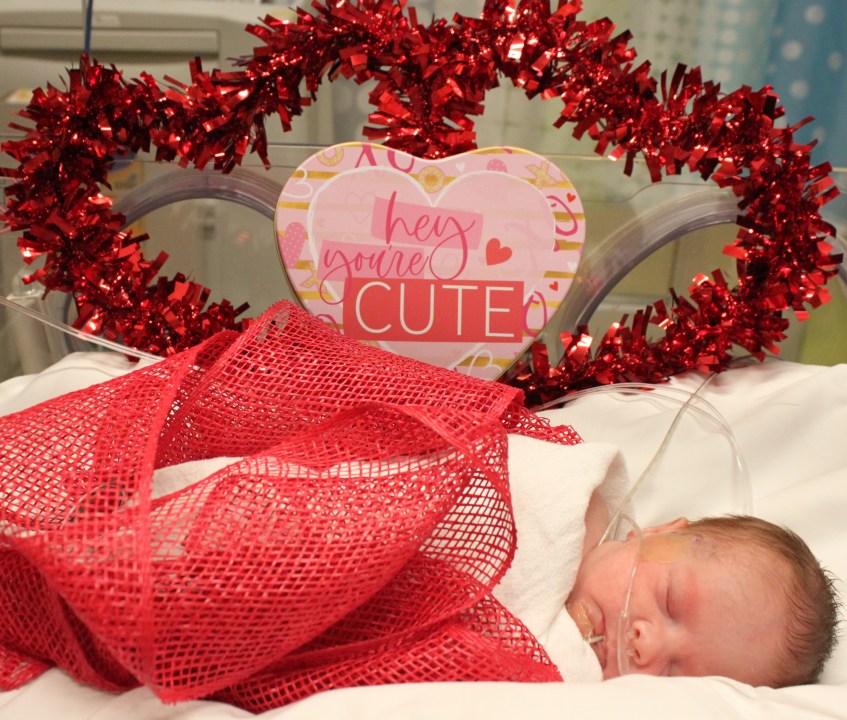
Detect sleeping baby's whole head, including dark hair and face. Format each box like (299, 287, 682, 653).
(568, 516, 838, 687)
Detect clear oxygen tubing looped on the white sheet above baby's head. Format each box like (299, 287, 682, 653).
(533, 373, 753, 542)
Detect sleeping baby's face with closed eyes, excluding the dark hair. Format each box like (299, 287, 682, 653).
(568, 529, 788, 685)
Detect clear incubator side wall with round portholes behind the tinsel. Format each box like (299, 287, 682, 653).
(2, 144, 847, 382)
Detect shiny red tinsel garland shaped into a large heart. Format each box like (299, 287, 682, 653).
(2, 0, 840, 404)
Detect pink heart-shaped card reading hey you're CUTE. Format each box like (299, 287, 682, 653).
(276, 142, 585, 379)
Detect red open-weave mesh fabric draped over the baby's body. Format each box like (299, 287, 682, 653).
(0, 303, 578, 711)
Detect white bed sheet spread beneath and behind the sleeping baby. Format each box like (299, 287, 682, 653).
(0, 353, 847, 720)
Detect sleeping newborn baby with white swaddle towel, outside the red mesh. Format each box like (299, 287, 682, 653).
(494, 437, 838, 687)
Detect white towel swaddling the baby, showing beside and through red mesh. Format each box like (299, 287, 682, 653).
(153, 435, 628, 682)
